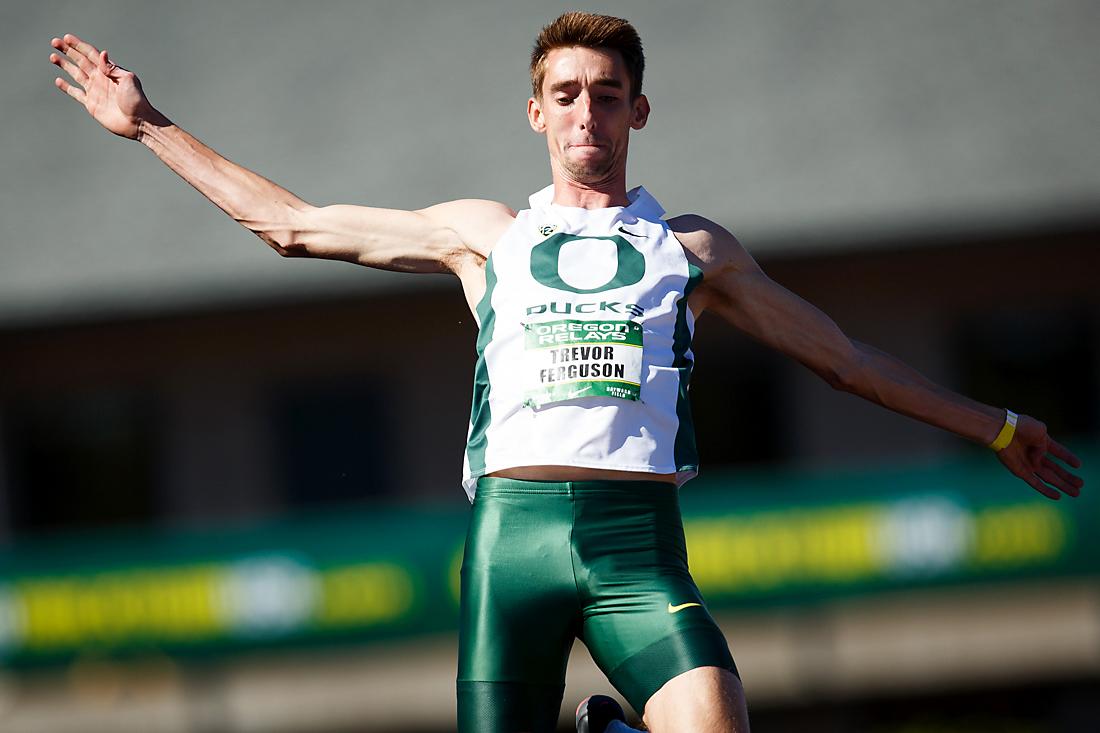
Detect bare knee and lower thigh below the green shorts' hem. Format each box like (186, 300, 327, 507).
(642, 667, 749, 733)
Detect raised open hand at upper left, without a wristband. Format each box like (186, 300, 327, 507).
(50, 34, 167, 140)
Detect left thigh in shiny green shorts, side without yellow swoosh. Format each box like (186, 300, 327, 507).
(458, 486, 579, 733)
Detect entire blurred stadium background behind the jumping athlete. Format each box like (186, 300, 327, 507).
(0, 0, 1100, 733)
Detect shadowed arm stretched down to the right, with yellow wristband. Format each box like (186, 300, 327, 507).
(670, 216, 1085, 499)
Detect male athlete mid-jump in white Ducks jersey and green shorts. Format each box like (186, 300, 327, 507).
(51, 13, 1084, 733)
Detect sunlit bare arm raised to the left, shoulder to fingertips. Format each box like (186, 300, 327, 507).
(50, 34, 514, 276)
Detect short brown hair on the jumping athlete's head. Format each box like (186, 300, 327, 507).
(531, 12, 646, 99)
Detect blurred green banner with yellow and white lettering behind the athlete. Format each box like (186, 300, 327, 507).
(0, 450, 1100, 666)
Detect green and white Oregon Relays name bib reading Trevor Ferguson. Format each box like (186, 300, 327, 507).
(524, 320, 641, 407)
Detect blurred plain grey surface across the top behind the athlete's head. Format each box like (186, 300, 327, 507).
(0, 0, 1100, 325)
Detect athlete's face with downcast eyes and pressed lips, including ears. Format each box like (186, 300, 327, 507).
(527, 46, 649, 185)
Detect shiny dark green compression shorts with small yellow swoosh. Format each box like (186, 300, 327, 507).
(458, 478, 737, 733)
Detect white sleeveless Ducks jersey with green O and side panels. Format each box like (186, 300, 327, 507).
(462, 186, 702, 501)
